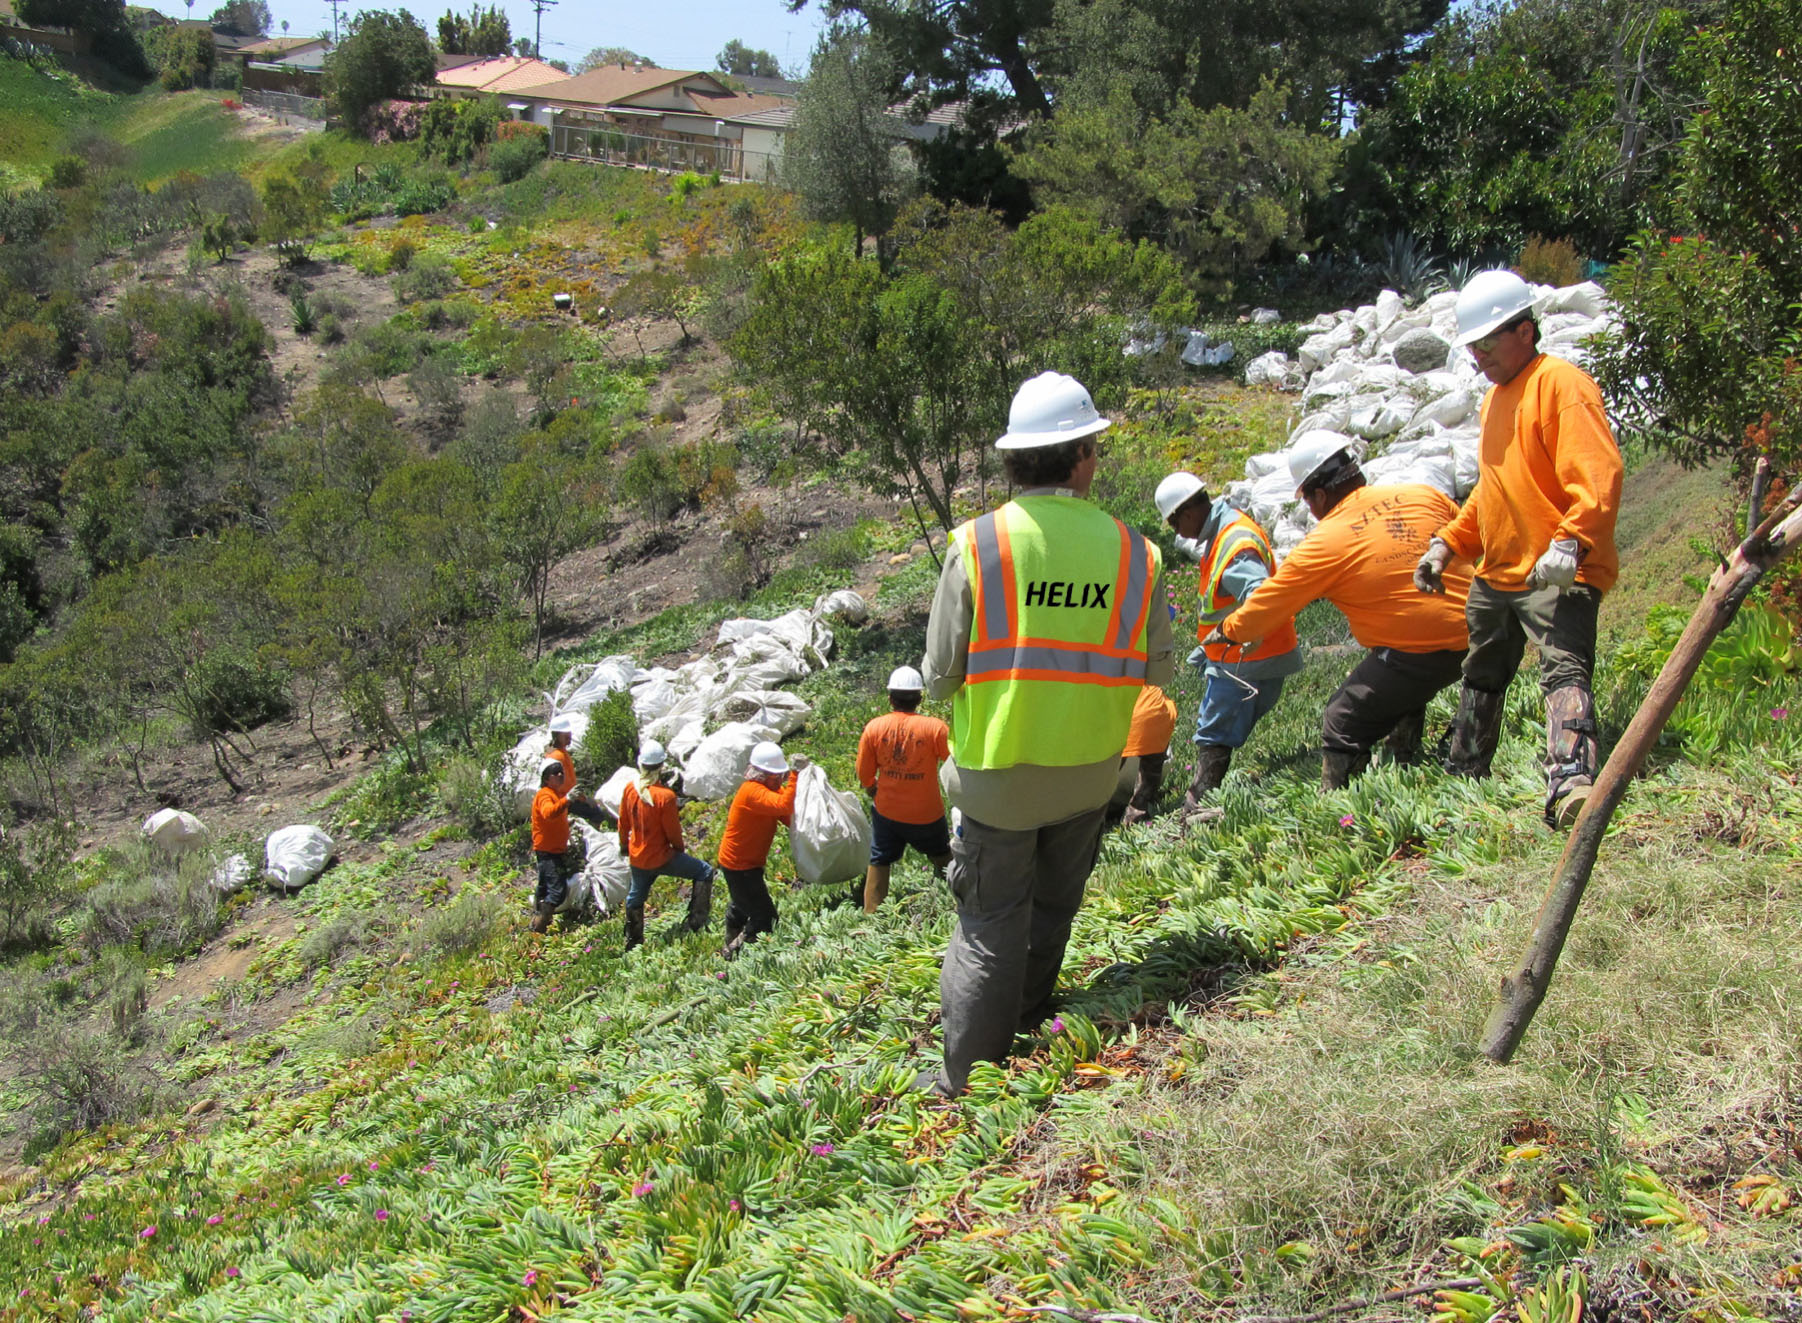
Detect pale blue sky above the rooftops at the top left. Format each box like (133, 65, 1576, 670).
(155, 0, 822, 72)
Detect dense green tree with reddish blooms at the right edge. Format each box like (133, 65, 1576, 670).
(1597, 0, 1802, 479)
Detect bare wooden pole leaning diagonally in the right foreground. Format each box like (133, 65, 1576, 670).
(1483, 488, 1802, 1065)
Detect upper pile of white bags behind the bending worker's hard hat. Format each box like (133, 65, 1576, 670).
(1225, 281, 1616, 557)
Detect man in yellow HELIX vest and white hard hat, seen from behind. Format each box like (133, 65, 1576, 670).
(924, 371, 1171, 1096)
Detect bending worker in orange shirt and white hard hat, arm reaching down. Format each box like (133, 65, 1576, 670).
(1220, 431, 1470, 789)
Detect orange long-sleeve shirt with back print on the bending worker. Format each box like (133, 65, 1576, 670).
(1220, 483, 1470, 652)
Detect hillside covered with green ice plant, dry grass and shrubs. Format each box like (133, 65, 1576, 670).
(0, 28, 1802, 1323)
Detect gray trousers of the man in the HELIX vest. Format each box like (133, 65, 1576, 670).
(939, 806, 1106, 1094)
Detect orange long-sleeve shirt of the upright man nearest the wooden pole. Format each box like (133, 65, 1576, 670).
(1438, 353, 1622, 593)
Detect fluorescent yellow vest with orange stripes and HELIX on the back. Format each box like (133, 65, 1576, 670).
(951, 496, 1160, 768)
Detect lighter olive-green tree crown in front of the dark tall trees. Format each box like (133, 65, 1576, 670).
(1015, 81, 1339, 285)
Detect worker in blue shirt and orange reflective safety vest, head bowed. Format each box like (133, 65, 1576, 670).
(1153, 472, 1301, 813)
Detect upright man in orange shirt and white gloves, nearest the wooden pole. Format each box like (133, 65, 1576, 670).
(1415, 270, 1622, 827)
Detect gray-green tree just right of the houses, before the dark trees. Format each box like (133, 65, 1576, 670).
(782, 27, 914, 254)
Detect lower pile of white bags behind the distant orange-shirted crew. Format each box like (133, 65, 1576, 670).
(497, 588, 869, 818)
